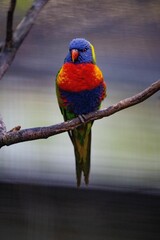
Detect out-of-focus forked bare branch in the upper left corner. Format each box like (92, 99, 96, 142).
(0, 0, 49, 79)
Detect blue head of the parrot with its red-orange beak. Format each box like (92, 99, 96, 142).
(64, 38, 96, 64)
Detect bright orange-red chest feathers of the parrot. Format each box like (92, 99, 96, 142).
(57, 63, 103, 92)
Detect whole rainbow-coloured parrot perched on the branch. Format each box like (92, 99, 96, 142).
(56, 38, 106, 186)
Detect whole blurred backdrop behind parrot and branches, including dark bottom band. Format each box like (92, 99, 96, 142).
(0, 0, 160, 240)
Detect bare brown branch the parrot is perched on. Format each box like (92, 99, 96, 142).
(0, 80, 160, 148)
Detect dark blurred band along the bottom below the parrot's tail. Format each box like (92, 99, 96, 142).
(0, 184, 160, 240)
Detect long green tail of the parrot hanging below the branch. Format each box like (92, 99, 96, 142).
(69, 122, 93, 187)
